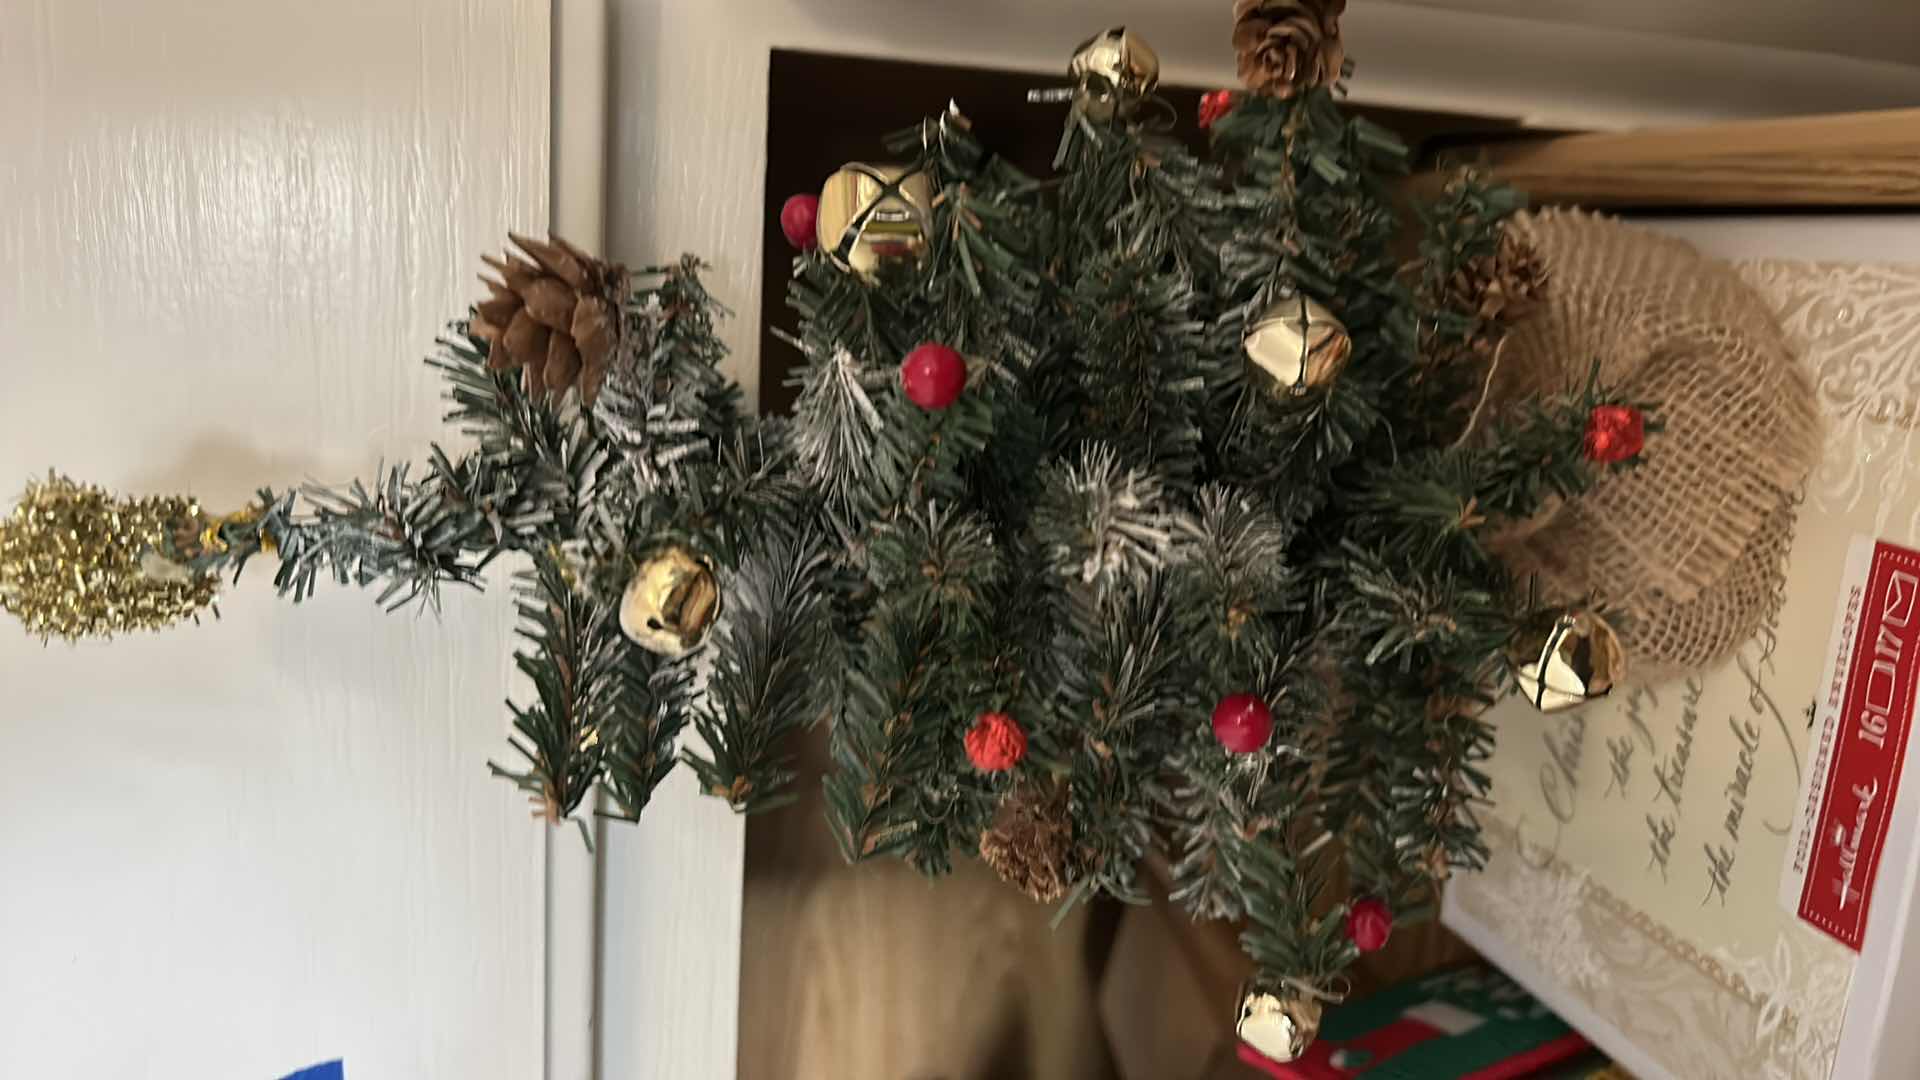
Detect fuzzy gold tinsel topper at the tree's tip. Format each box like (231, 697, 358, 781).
(0, 473, 217, 640)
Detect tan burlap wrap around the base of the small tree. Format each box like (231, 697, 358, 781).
(1490, 211, 1822, 676)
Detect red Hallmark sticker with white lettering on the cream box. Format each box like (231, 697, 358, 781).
(1795, 544, 1920, 951)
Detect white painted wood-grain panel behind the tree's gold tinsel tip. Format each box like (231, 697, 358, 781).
(0, 0, 549, 1080)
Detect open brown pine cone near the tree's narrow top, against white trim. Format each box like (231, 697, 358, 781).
(470, 233, 628, 405)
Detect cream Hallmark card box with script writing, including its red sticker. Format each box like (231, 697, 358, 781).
(1444, 221, 1920, 1080)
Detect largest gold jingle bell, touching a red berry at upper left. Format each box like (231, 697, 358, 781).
(814, 161, 933, 277)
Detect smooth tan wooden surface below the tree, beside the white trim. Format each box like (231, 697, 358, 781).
(739, 722, 1116, 1080)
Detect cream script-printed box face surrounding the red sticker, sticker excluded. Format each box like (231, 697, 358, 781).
(1448, 253, 1920, 1080)
